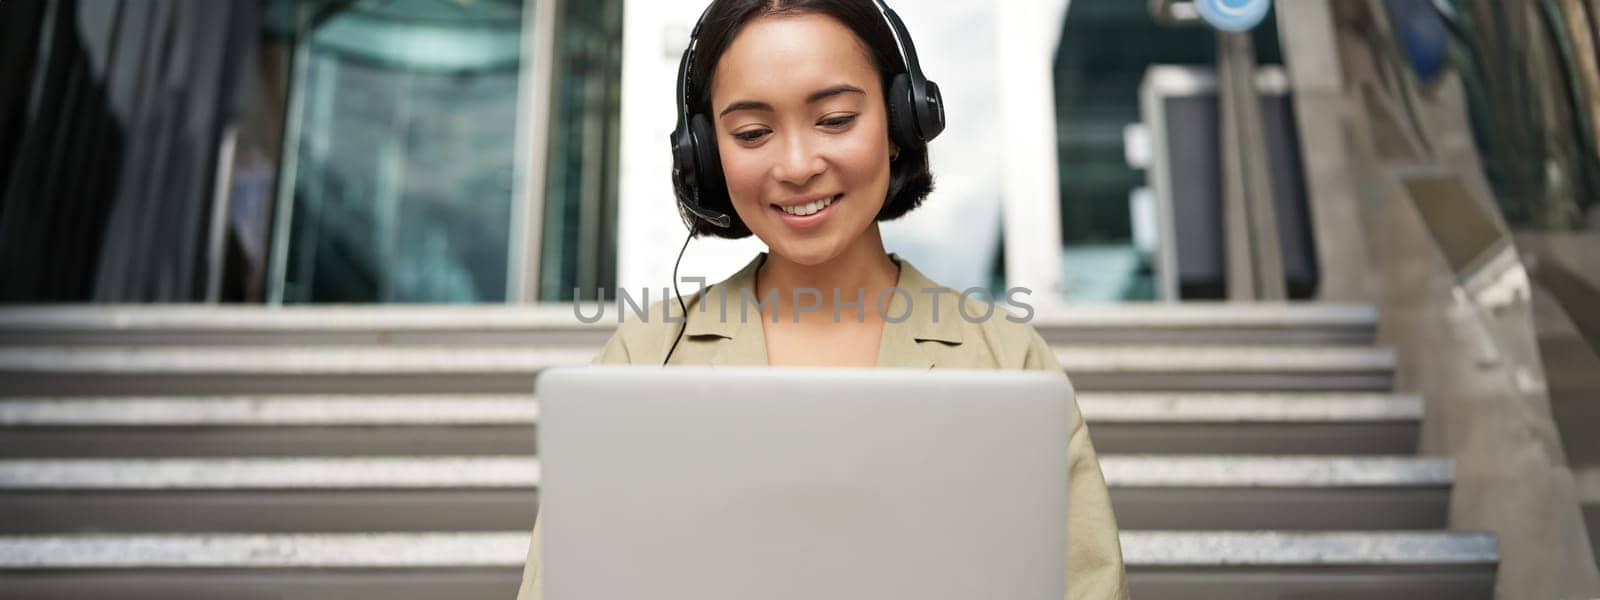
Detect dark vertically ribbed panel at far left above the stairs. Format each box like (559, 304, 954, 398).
(0, 0, 258, 301)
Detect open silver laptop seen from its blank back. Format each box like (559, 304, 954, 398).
(538, 366, 1072, 600)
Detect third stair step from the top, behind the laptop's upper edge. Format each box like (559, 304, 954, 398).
(0, 392, 1422, 458)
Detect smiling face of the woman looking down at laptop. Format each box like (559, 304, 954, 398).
(710, 14, 893, 264)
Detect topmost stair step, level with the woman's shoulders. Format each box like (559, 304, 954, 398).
(0, 302, 1378, 347)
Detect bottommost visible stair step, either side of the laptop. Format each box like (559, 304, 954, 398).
(0, 531, 1499, 600)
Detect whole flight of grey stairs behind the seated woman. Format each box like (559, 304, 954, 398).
(0, 306, 1498, 600)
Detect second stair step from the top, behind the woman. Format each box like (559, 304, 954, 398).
(0, 346, 1395, 397)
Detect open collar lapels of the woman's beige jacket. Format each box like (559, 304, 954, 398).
(683, 253, 963, 368)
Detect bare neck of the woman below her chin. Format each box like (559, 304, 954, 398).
(755, 222, 899, 322)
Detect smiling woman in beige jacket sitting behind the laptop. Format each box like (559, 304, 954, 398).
(518, 0, 1128, 600)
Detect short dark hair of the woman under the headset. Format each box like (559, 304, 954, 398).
(678, 0, 933, 240)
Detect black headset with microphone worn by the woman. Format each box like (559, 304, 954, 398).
(672, 0, 944, 229)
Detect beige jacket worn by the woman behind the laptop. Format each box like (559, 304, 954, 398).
(517, 253, 1128, 600)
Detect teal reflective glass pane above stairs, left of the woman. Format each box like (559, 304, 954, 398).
(278, 0, 523, 302)
